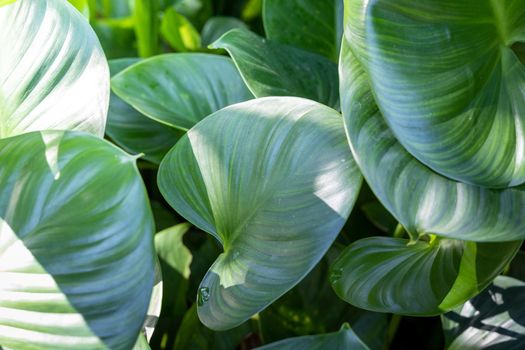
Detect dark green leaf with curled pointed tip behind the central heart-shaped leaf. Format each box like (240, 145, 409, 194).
(210, 29, 339, 108)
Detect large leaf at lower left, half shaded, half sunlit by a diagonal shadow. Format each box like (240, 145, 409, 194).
(0, 131, 154, 349)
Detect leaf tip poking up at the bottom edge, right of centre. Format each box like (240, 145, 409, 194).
(257, 324, 370, 350)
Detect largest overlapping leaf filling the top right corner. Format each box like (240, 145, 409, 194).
(346, 0, 525, 188)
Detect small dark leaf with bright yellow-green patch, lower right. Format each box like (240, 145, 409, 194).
(330, 237, 522, 316)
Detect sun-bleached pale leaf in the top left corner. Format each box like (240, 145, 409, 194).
(0, 0, 109, 138)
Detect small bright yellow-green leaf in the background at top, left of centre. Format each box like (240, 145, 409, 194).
(161, 8, 201, 52)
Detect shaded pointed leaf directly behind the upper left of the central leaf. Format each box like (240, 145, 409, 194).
(111, 54, 252, 131)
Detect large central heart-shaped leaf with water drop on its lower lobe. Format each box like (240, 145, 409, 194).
(158, 97, 361, 330)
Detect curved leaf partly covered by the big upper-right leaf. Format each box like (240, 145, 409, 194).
(340, 37, 525, 242)
